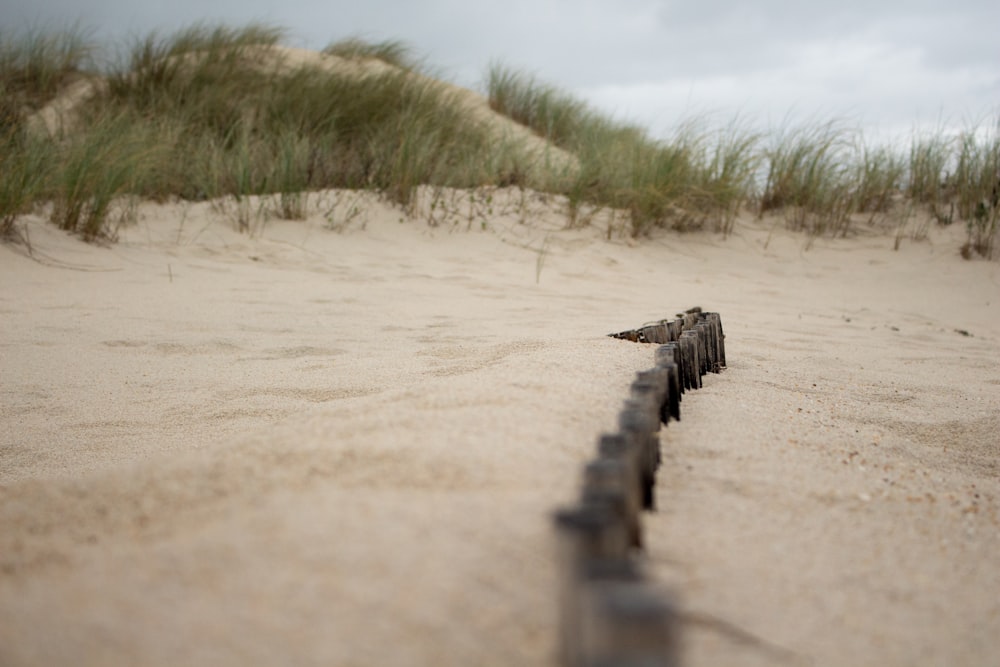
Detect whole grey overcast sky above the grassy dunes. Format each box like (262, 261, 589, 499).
(0, 0, 1000, 141)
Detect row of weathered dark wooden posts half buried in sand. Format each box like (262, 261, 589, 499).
(555, 308, 726, 667)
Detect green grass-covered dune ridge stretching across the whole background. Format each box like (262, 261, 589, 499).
(0, 24, 1000, 257)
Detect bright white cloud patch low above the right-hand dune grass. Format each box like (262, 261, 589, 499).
(580, 21, 1000, 141)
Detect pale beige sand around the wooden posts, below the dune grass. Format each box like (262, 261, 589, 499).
(0, 191, 1000, 666)
